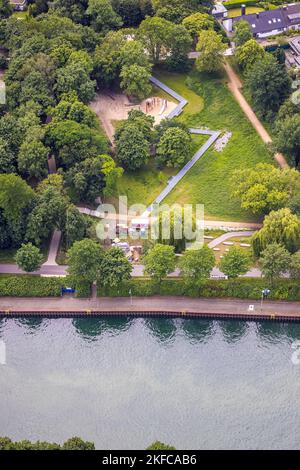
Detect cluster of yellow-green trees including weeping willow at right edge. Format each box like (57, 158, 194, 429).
(232, 164, 300, 278)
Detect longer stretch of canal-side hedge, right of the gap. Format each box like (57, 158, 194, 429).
(98, 278, 300, 300)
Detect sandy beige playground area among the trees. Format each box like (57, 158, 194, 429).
(90, 92, 177, 142)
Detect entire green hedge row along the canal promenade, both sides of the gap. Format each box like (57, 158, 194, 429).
(0, 275, 300, 300)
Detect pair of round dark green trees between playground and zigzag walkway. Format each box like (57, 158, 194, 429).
(115, 110, 192, 171)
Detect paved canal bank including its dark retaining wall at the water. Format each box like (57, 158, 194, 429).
(0, 296, 300, 321)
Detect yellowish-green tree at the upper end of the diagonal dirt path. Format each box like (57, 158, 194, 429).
(196, 30, 225, 73)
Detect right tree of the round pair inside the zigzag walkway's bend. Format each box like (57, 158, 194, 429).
(156, 127, 192, 168)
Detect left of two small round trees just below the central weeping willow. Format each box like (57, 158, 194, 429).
(143, 243, 175, 284)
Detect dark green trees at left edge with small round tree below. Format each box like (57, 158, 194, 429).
(0, 174, 90, 272)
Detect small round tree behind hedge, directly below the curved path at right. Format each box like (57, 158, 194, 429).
(220, 246, 251, 279)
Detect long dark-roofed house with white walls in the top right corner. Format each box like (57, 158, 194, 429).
(223, 3, 300, 38)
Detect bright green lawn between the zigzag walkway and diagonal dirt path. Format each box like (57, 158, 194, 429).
(155, 67, 273, 221)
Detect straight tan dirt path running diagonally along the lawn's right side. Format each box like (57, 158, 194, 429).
(224, 62, 288, 168)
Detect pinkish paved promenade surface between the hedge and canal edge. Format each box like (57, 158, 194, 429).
(0, 296, 300, 319)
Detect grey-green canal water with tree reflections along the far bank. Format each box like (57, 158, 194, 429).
(0, 318, 300, 449)
